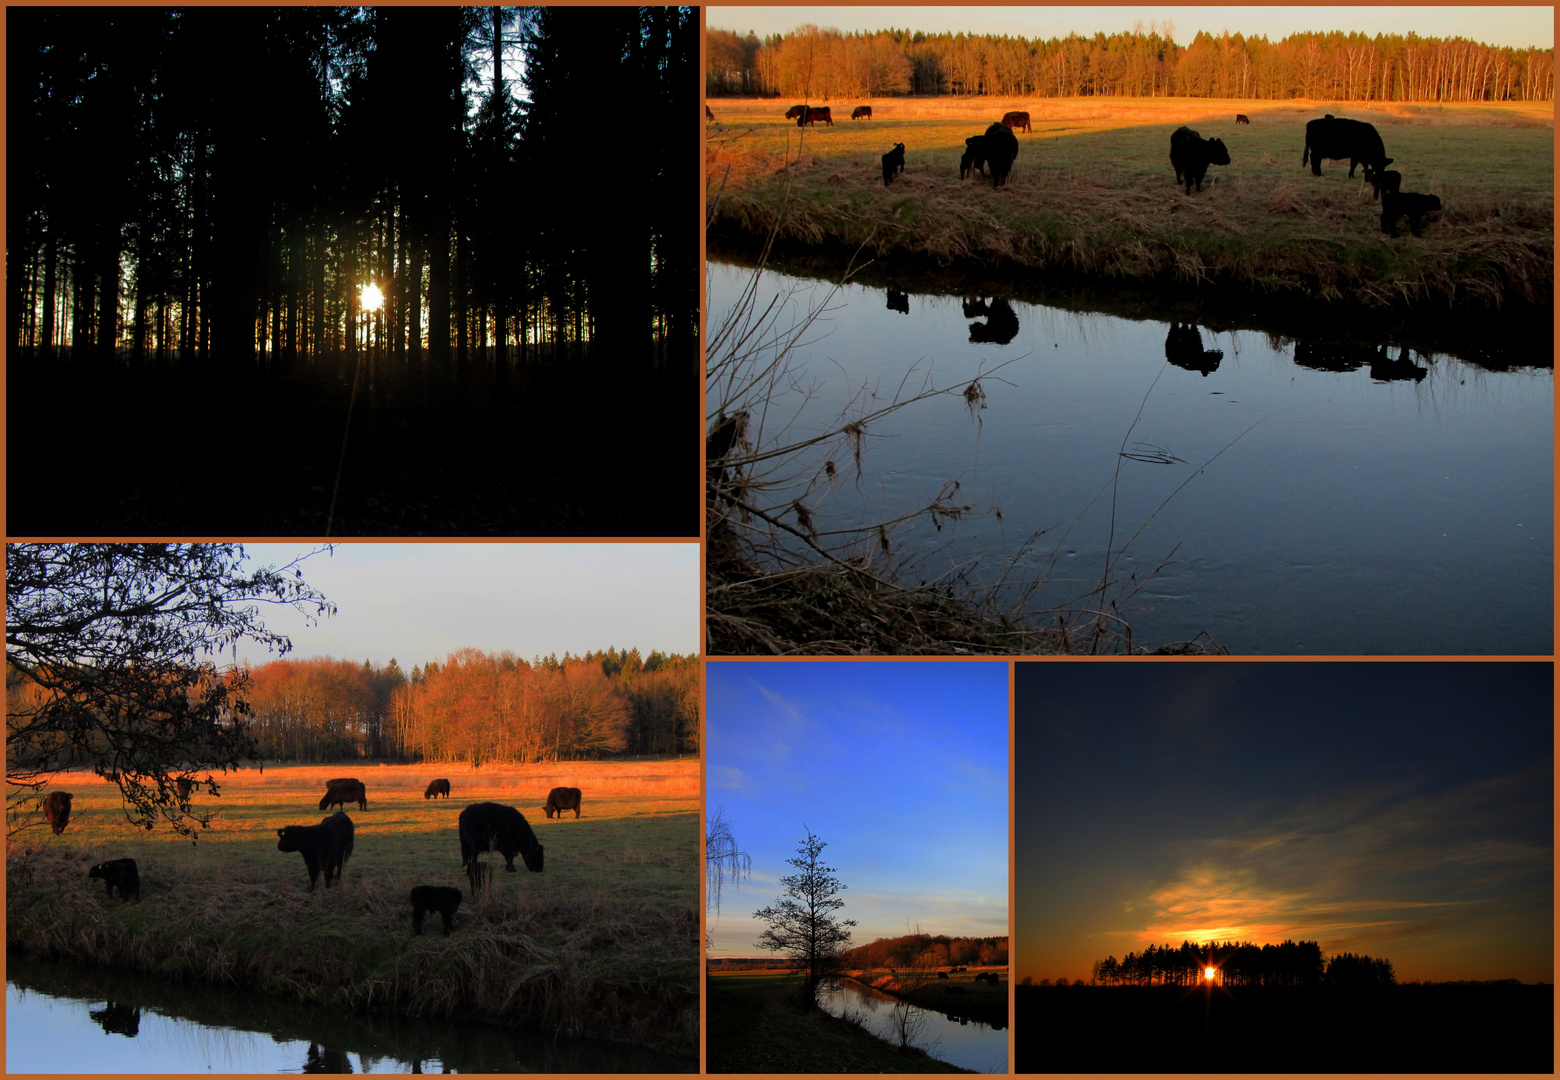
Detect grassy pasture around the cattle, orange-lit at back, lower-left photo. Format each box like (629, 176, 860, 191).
(6, 760, 702, 1053)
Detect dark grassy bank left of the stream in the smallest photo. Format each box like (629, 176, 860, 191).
(705, 971, 967, 1072)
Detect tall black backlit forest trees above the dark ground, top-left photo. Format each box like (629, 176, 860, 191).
(6, 8, 699, 371)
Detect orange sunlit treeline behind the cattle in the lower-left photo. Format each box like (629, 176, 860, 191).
(241, 649, 699, 765)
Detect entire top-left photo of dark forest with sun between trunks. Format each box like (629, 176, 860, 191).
(6, 8, 700, 537)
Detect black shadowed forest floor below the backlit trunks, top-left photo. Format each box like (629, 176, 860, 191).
(6, 352, 699, 537)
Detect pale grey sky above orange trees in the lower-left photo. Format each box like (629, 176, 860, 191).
(221, 543, 699, 671)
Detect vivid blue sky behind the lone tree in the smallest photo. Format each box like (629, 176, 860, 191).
(705, 662, 1008, 957)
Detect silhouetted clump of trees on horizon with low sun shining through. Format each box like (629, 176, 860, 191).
(1085, 941, 1396, 986)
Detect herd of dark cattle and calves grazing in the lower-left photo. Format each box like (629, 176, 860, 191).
(44, 776, 580, 936)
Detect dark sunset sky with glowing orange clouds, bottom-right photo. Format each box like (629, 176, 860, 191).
(1014, 663, 1554, 983)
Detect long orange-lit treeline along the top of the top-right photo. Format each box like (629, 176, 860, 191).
(705, 25, 1554, 101)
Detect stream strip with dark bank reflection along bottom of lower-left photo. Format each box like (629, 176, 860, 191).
(5, 954, 699, 1074)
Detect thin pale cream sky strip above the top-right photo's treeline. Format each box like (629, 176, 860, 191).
(705, 5, 1555, 48)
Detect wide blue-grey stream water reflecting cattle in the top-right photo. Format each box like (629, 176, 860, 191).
(708, 262, 1554, 655)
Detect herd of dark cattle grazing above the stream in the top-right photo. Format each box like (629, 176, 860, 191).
(704, 105, 1441, 236)
